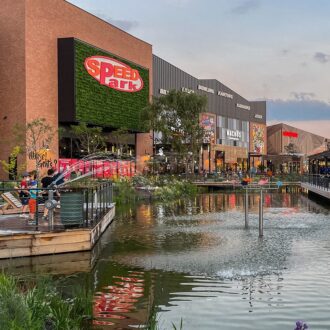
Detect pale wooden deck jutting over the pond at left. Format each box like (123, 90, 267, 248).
(0, 204, 115, 259)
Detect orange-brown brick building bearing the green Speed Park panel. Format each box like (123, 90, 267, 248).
(0, 0, 152, 177)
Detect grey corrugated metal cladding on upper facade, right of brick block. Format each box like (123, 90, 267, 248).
(153, 55, 266, 124)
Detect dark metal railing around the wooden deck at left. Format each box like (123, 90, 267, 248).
(0, 181, 113, 230)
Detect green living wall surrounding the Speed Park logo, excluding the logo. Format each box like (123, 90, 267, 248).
(75, 40, 149, 132)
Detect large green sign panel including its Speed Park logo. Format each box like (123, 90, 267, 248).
(69, 38, 150, 132)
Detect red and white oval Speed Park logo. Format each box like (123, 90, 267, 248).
(84, 56, 143, 93)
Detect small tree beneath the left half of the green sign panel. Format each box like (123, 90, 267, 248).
(71, 122, 105, 154)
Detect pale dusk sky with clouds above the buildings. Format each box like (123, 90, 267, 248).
(69, 0, 330, 138)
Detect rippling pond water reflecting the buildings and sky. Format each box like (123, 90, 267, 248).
(1, 193, 330, 330)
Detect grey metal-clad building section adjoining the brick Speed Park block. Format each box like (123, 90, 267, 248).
(153, 55, 267, 172)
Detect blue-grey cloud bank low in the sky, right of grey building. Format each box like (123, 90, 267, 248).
(267, 99, 330, 122)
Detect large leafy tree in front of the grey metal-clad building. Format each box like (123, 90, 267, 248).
(142, 90, 207, 171)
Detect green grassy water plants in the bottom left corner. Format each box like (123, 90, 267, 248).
(0, 273, 92, 330)
